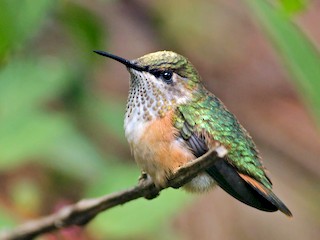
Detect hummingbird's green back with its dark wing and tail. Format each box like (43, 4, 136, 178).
(175, 93, 291, 216)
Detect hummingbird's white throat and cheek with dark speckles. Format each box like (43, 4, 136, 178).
(124, 68, 191, 142)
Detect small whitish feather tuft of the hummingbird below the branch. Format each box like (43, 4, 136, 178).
(183, 173, 216, 193)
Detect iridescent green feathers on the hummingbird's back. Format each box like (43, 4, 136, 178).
(174, 87, 272, 189)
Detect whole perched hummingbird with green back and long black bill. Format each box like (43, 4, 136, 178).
(94, 51, 292, 217)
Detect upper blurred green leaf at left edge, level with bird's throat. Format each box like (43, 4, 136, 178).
(0, 58, 70, 118)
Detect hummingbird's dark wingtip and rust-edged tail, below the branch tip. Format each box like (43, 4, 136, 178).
(207, 159, 292, 216)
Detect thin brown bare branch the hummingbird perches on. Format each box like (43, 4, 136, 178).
(0, 146, 227, 240)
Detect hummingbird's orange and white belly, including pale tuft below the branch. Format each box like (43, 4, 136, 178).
(125, 110, 214, 192)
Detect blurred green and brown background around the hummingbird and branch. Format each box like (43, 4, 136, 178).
(0, 0, 320, 240)
